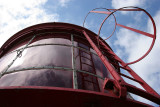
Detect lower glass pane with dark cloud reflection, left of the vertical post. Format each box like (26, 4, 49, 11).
(0, 69, 72, 88)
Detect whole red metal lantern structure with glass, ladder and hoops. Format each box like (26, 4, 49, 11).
(0, 7, 160, 107)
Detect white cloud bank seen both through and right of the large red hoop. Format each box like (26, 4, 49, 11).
(115, 10, 160, 104)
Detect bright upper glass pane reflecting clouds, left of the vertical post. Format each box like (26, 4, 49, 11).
(9, 45, 72, 71)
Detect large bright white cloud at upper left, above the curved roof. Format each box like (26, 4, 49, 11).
(0, 0, 59, 46)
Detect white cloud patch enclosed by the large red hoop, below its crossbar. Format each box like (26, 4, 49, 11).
(115, 29, 152, 62)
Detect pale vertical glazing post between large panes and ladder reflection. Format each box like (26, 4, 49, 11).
(71, 34, 78, 89)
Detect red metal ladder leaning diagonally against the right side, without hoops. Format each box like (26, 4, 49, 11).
(83, 31, 160, 104)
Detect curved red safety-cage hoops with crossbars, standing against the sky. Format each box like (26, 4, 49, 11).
(83, 6, 156, 66)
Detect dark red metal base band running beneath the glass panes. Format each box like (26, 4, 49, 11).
(0, 86, 152, 107)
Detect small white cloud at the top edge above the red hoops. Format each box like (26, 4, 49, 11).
(112, 0, 146, 9)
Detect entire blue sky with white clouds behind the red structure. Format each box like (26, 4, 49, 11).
(0, 0, 160, 104)
